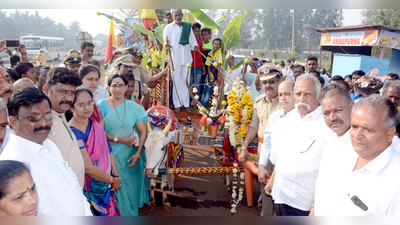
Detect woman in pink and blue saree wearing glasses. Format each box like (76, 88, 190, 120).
(68, 87, 121, 216)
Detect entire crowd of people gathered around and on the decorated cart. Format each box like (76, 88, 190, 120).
(0, 9, 400, 216)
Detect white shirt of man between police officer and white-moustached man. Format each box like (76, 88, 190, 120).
(258, 109, 286, 167)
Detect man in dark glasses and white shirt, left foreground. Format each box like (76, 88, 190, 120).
(0, 87, 92, 216)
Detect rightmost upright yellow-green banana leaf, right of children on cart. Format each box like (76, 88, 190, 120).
(222, 12, 247, 50)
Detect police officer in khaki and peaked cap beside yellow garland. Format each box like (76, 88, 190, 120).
(239, 63, 282, 216)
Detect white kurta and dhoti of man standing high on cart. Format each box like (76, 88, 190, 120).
(164, 22, 198, 108)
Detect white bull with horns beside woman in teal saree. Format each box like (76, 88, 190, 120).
(144, 118, 175, 212)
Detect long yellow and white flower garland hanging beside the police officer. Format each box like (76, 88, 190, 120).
(225, 78, 253, 215)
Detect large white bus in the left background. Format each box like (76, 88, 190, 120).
(19, 36, 66, 59)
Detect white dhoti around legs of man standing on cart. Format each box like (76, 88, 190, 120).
(172, 66, 189, 108)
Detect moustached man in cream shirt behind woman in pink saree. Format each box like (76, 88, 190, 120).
(43, 67, 85, 187)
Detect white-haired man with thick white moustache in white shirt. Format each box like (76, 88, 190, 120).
(265, 74, 328, 216)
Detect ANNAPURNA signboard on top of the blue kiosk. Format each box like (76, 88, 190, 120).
(321, 30, 379, 46)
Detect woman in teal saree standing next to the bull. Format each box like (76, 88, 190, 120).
(97, 74, 149, 216)
